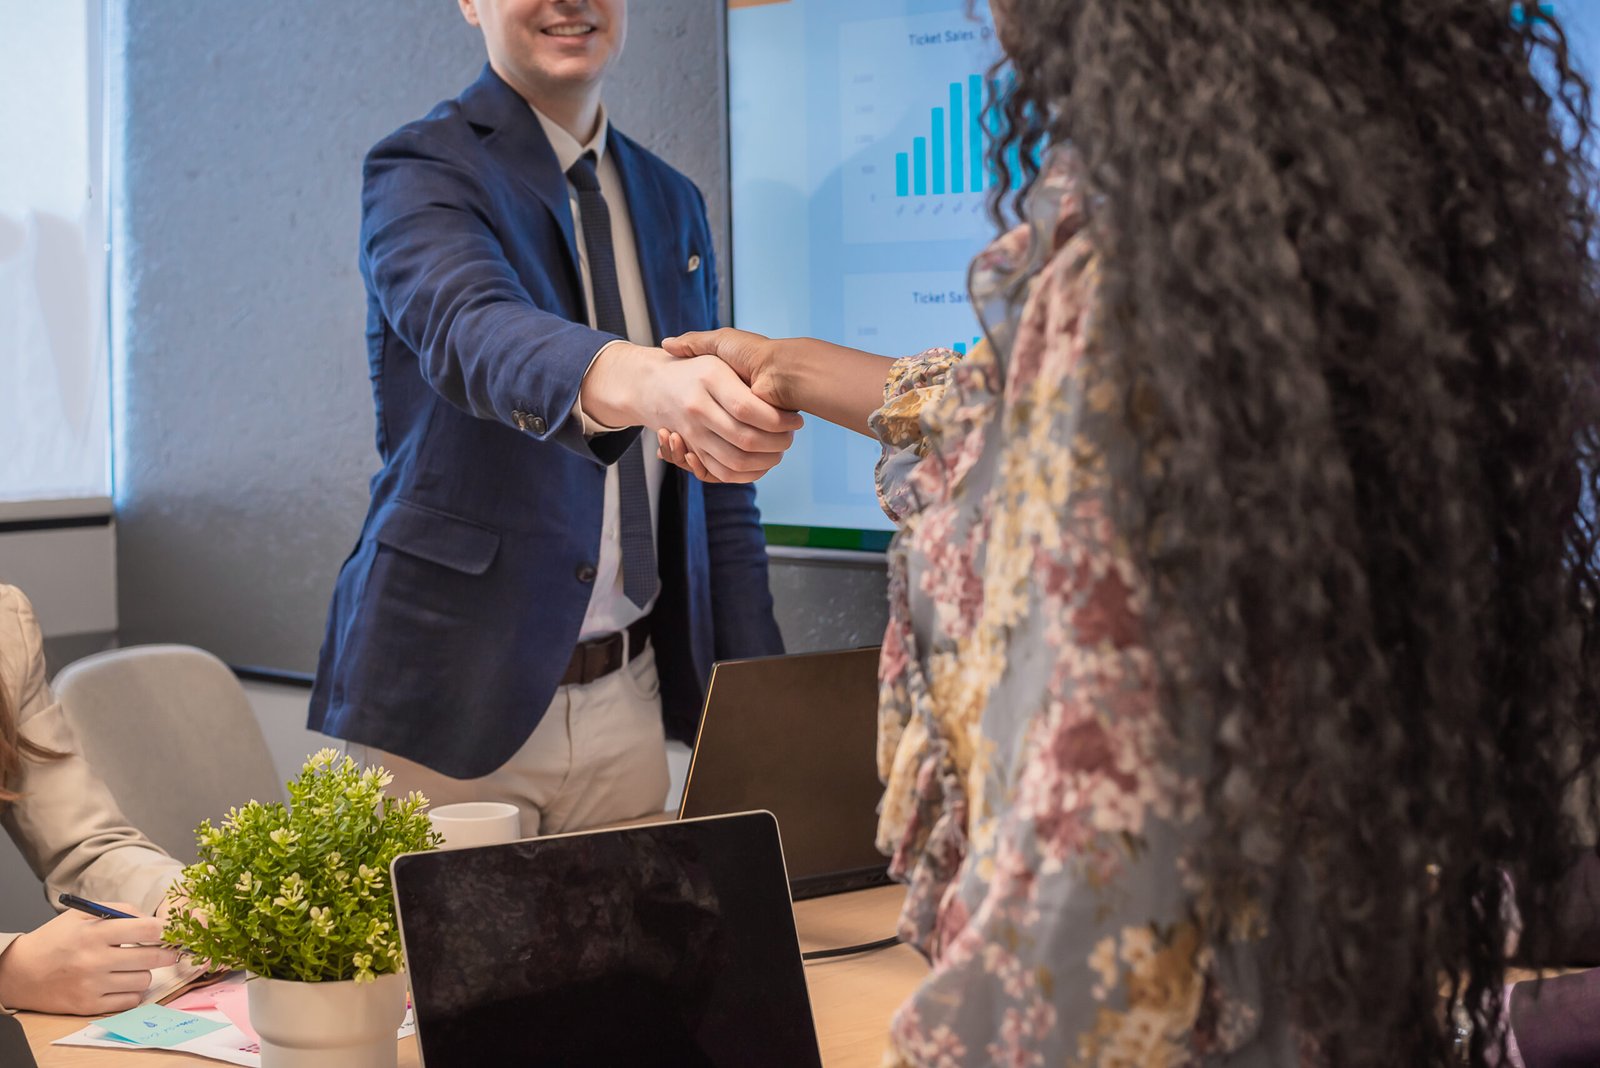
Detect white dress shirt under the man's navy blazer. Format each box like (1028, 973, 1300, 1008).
(533, 107, 666, 638)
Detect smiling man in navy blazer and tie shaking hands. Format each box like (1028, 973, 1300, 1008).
(309, 0, 798, 835)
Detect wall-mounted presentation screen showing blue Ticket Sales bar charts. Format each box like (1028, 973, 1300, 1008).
(728, 0, 998, 548)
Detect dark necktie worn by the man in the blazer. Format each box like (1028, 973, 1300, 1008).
(566, 152, 661, 608)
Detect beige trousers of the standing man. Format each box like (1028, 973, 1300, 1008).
(344, 648, 667, 838)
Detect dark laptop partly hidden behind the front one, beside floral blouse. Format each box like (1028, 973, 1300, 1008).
(678, 646, 888, 899)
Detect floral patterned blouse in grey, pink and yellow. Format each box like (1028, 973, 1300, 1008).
(872, 152, 1306, 1068)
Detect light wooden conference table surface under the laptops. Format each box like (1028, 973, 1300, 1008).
(18, 886, 928, 1068)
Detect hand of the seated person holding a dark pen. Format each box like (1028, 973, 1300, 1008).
(0, 903, 178, 1015)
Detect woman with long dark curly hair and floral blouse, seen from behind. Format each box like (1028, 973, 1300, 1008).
(662, 0, 1600, 1068)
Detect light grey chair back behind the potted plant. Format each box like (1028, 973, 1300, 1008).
(54, 646, 285, 863)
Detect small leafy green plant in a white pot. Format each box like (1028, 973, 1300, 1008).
(166, 748, 440, 1068)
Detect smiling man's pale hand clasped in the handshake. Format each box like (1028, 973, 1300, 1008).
(579, 344, 805, 483)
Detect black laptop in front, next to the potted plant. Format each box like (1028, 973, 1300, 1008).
(390, 812, 822, 1068)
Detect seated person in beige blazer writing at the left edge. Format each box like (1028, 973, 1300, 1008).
(0, 584, 182, 1015)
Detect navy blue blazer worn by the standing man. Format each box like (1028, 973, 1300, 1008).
(309, 67, 782, 779)
